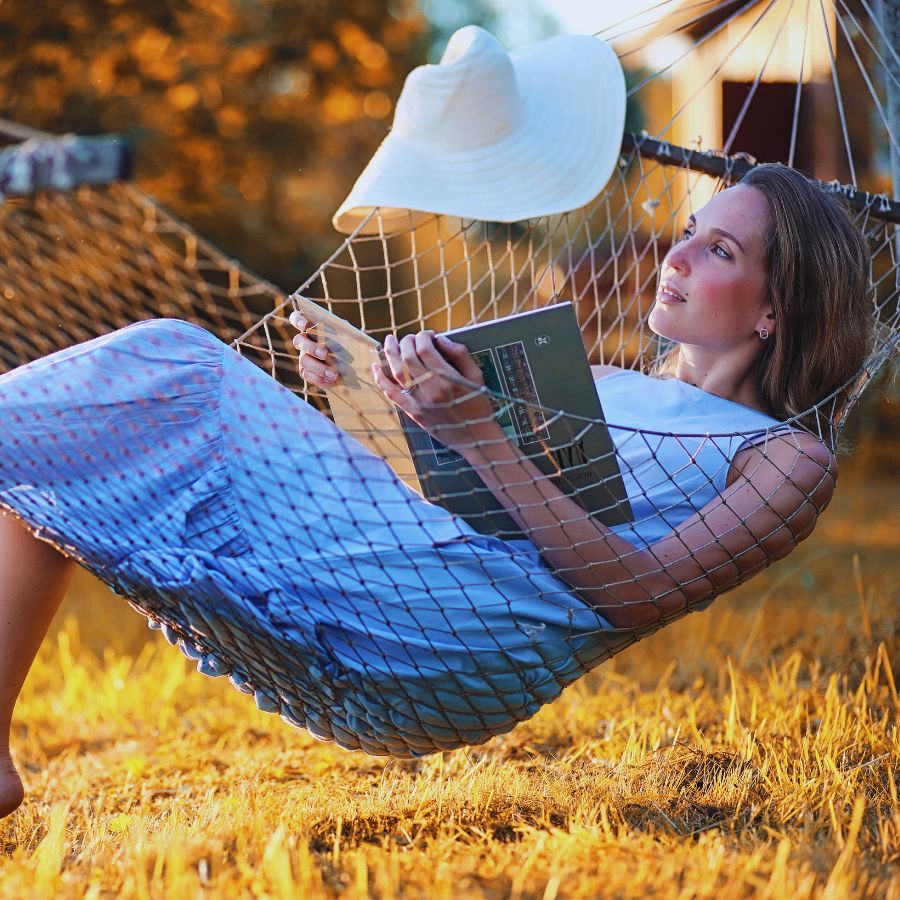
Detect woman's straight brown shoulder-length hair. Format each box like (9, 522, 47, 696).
(741, 164, 874, 419)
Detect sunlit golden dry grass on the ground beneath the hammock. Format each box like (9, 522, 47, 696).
(0, 474, 900, 900)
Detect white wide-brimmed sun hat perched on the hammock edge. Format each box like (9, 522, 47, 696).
(332, 25, 625, 234)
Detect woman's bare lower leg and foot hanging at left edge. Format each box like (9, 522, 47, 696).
(0, 515, 74, 818)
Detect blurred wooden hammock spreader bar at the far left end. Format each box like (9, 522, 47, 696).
(0, 134, 134, 199)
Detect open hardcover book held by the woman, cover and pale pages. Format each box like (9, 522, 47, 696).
(292, 295, 632, 540)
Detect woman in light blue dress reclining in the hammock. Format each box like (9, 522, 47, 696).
(0, 166, 871, 815)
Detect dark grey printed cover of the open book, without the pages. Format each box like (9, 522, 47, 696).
(400, 303, 632, 539)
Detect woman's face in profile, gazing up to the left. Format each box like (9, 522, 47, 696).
(648, 185, 775, 352)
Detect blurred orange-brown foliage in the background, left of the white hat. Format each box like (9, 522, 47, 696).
(0, 0, 432, 288)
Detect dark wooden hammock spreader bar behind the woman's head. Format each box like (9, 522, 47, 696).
(622, 131, 900, 225)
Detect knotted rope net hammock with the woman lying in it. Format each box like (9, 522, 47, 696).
(0, 0, 900, 756)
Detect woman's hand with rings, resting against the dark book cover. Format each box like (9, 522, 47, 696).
(372, 331, 505, 456)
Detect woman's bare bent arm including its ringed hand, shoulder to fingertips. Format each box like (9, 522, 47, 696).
(375, 332, 836, 627)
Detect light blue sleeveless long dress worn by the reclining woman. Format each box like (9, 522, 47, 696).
(0, 320, 772, 756)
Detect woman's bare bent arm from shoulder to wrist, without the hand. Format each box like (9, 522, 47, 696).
(465, 435, 836, 627)
